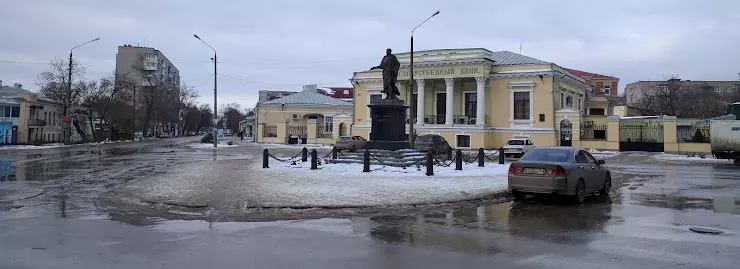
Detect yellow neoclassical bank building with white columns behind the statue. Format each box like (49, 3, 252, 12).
(351, 48, 590, 148)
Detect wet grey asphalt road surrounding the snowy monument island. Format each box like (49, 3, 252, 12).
(0, 139, 740, 268)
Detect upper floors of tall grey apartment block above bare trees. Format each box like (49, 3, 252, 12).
(116, 45, 180, 92)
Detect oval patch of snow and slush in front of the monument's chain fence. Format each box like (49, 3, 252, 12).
(124, 160, 509, 208)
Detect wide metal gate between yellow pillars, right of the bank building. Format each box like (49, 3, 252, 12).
(619, 120, 664, 152)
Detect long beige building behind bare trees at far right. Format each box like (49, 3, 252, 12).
(624, 79, 740, 107)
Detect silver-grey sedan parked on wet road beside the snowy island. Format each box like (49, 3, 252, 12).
(509, 147, 612, 203)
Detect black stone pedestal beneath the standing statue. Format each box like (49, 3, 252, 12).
(365, 99, 410, 150)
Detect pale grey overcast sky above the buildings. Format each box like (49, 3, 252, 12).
(0, 0, 740, 106)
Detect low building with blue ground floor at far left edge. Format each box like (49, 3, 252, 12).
(0, 81, 62, 144)
